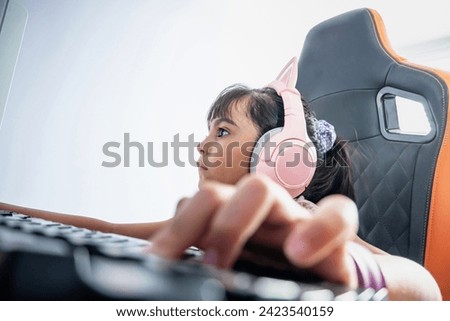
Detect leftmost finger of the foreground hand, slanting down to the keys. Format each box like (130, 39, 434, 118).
(149, 182, 235, 259)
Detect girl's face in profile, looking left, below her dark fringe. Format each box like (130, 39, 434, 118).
(198, 102, 258, 186)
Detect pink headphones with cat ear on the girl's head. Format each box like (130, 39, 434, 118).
(250, 57, 317, 197)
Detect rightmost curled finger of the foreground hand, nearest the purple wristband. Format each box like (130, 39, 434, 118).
(284, 195, 358, 267)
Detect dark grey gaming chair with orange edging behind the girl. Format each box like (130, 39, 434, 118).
(296, 9, 450, 300)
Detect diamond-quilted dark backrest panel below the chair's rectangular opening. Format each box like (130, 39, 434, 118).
(351, 136, 423, 261)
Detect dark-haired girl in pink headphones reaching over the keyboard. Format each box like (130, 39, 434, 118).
(0, 60, 441, 300)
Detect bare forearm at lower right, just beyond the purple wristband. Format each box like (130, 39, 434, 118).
(375, 254, 442, 301)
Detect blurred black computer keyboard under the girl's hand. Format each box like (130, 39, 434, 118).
(0, 210, 388, 301)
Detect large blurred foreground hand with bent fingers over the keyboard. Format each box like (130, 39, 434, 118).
(151, 175, 358, 287)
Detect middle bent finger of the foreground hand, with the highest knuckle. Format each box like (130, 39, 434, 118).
(205, 175, 309, 268)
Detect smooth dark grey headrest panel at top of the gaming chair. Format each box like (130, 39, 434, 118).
(299, 9, 393, 101)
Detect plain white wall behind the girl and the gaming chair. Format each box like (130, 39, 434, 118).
(0, 0, 450, 222)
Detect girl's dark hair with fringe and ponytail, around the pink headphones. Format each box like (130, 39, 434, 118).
(207, 84, 354, 203)
